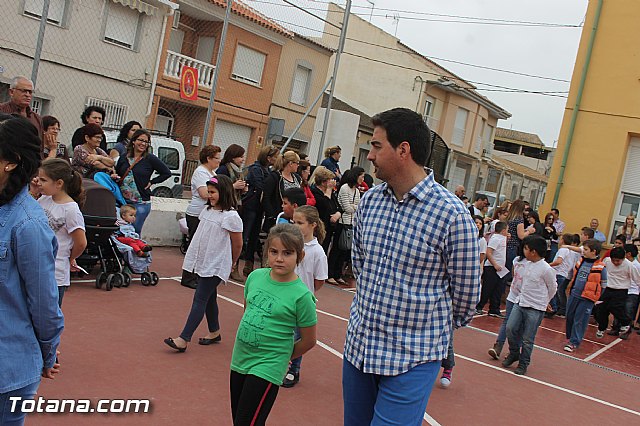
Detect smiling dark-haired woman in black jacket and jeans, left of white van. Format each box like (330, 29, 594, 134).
(116, 129, 171, 234)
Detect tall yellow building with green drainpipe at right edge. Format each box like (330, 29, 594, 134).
(541, 0, 640, 241)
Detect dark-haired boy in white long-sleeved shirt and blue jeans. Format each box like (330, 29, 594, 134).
(502, 235, 558, 375)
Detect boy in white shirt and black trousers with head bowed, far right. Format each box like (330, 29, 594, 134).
(596, 247, 640, 340)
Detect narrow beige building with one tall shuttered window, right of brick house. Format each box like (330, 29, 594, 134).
(267, 34, 333, 152)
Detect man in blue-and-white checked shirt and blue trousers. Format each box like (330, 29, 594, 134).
(342, 108, 480, 426)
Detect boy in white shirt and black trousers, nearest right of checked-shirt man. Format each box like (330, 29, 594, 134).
(476, 222, 509, 318)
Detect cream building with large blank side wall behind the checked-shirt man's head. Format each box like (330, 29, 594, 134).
(323, 3, 511, 194)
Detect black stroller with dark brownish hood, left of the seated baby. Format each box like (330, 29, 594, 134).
(76, 179, 158, 291)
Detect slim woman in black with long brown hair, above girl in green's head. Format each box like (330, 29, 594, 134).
(241, 145, 280, 277)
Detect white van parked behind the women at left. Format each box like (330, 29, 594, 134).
(104, 130, 185, 198)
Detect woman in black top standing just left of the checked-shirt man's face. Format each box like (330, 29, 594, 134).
(310, 166, 341, 253)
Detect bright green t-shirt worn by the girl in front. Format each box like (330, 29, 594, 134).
(231, 268, 318, 386)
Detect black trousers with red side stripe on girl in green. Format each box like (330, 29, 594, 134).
(230, 370, 280, 426)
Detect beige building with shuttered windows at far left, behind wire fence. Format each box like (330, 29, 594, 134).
(0, 0, 176, 143)
